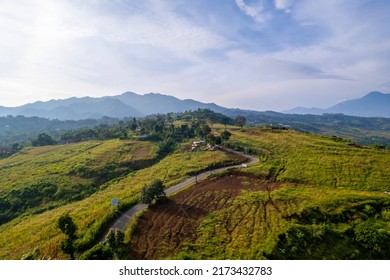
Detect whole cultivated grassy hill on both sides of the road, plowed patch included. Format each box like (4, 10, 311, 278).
(0, 117, 390, 259)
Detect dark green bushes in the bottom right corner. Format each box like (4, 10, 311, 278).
(265, 201, 390, 259)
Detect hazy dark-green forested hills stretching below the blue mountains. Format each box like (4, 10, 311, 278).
(0, 109, 390, 151)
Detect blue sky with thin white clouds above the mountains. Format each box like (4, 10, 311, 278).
(0, 0, 390, 111)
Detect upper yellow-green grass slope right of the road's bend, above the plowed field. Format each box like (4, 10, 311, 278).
(224, 128, 390, 191)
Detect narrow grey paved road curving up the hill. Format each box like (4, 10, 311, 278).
(102, 147, 259, 238)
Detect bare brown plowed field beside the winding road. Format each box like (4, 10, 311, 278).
(130, 175, 277, 259)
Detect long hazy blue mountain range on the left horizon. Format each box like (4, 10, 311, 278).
(0, 92, 224, 120)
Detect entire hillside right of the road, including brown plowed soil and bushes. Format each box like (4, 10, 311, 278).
(129, 127, 390, 259)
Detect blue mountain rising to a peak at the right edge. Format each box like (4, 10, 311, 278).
(283, 91, 390, 118)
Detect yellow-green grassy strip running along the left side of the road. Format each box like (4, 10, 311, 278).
(0, 144, 241, 259)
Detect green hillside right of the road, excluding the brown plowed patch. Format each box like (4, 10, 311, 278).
(173, 128, 390, 259)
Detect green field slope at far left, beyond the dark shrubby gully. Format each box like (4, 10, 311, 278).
(0, 140, 157, 224)
